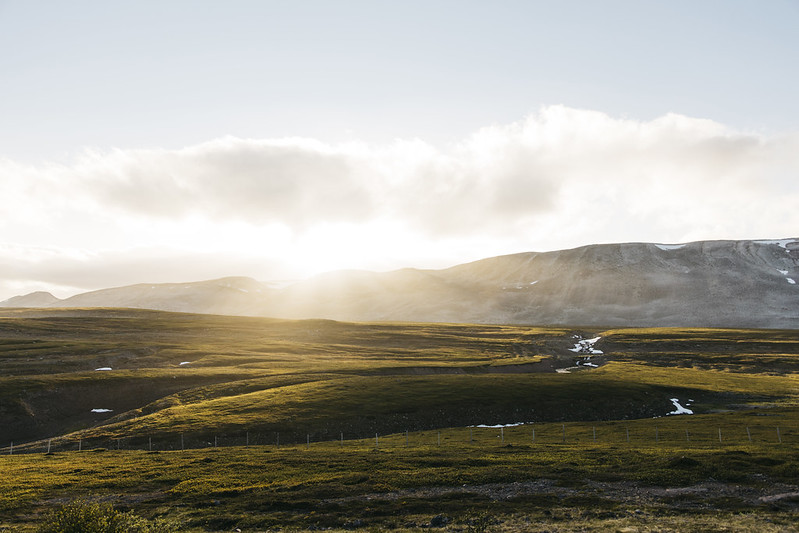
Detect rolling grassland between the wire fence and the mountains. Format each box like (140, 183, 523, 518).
(0, 309, 799, 444)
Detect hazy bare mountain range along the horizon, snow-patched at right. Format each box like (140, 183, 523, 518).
(6, 239, 799, 328)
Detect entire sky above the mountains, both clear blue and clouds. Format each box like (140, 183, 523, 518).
(0, 0, 799, 300)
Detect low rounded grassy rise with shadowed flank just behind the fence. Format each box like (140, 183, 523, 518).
(43, 362, 797, 444)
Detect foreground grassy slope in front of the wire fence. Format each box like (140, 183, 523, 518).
(0, 428, 799, 531)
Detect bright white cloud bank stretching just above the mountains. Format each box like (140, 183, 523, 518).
(0, 106, 799, 296)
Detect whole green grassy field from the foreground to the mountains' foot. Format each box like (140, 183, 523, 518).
(0, 310, 799, 531)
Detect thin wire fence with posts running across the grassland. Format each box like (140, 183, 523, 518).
(0, 424, 799, 455)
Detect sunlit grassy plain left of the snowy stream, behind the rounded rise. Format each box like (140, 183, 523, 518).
(0, 310, 576, 442)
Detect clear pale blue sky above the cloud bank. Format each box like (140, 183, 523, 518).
(0, 0, 799, 161)
